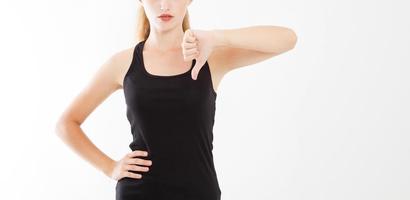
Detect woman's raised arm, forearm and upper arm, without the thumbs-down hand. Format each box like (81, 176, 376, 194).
(211, 25, 297, 71)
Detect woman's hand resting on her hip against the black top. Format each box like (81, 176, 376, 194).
(108, 150, 152, 180)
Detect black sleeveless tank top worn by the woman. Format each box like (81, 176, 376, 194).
(116, 40, 221, 200)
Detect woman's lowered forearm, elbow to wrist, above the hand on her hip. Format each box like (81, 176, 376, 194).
(56, 121, 115, 176)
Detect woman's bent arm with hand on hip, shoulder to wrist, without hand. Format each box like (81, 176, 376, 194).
(55, 49, 132, 175)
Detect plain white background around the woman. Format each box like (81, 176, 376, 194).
(0, 0, 410, 200)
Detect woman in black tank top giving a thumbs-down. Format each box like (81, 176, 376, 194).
(56, 0, 296, 200)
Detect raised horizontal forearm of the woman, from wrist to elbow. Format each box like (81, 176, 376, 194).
(213, 25, 297, 53)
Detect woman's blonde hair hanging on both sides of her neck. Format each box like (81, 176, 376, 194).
(135, 5, 190, 42)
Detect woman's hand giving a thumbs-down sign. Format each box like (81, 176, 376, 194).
(181, 29, 215, 80)
